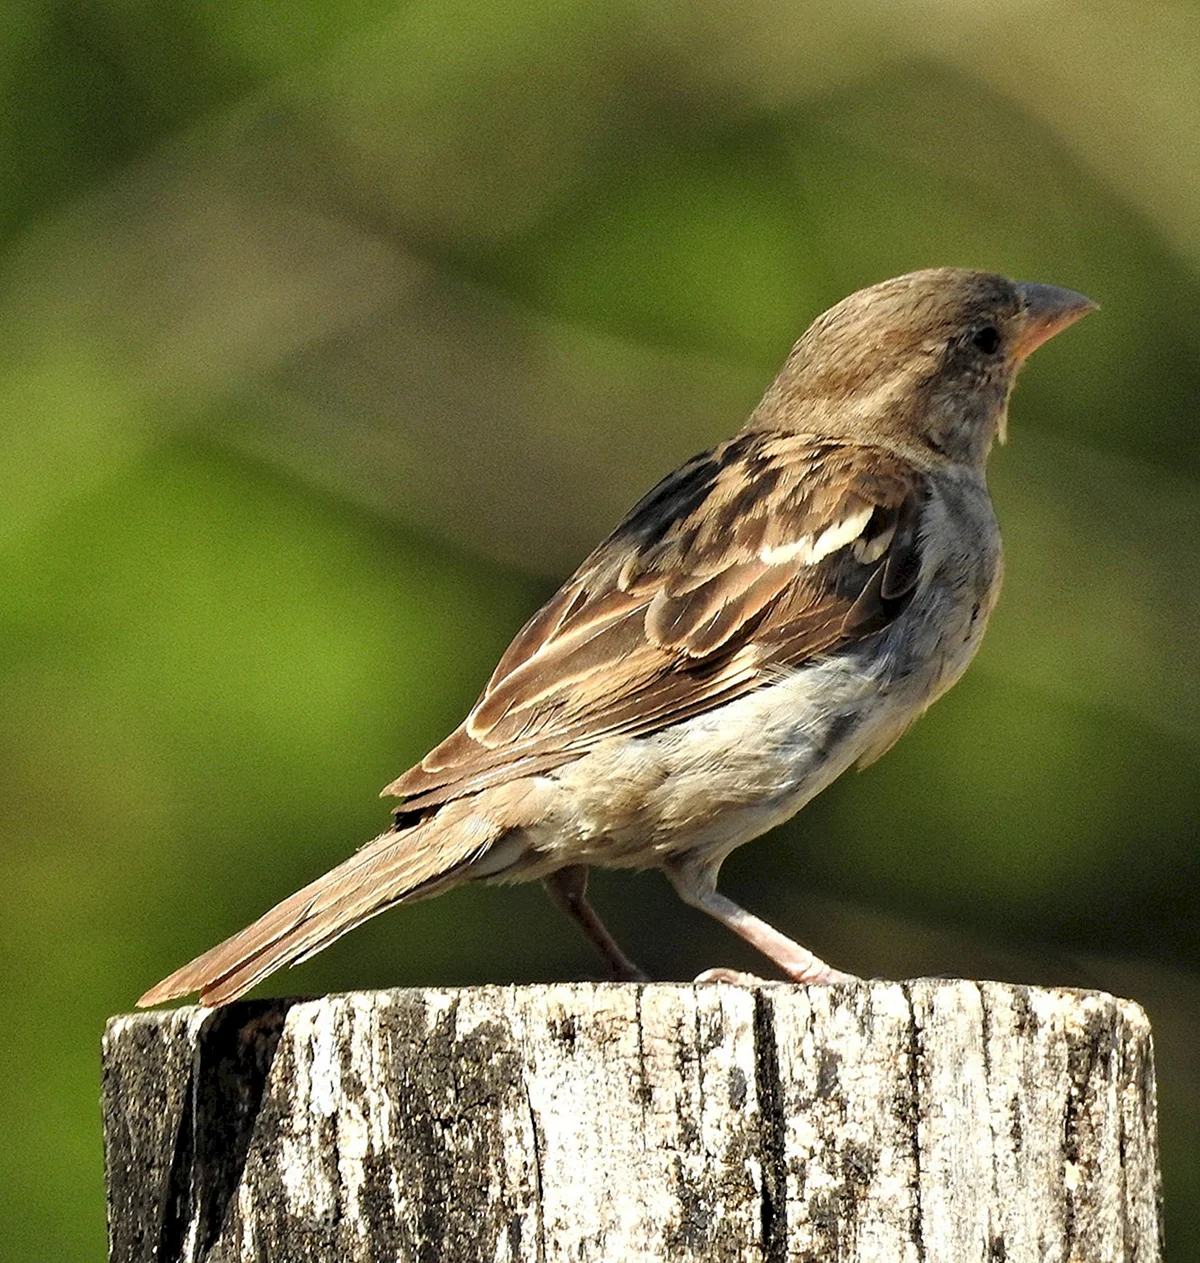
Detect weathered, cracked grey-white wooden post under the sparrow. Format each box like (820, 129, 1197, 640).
(104, 980, 1161, 1263)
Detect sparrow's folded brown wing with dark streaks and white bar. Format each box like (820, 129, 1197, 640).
(384, 433, 926, 815)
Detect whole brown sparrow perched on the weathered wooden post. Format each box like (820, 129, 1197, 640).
(138, 268, 1095, 1005)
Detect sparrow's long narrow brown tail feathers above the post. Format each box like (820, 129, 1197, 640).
(138, 805, 498, 1008)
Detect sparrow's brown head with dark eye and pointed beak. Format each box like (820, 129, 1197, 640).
(749, 268, 1096, 469)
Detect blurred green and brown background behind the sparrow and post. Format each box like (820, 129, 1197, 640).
(0, 0, 1200, 1260)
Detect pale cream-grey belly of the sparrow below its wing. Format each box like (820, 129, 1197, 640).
(520, 553, 999, 868)
